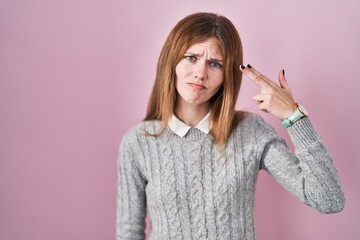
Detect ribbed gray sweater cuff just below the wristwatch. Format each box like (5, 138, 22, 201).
(287, 117, 320, 149)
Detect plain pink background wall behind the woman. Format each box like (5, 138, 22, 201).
(0, 0, 360, 240)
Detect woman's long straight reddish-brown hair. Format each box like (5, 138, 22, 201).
(144, 12, 244, 147)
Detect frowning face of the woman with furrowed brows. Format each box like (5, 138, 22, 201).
(175, 38, 224, 107)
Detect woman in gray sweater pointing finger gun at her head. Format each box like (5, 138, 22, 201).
(117, 13, 344, 240)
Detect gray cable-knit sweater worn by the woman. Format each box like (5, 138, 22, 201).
(116, 115, 344, 240)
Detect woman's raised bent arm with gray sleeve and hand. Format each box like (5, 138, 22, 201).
(240, 65, 345, 213)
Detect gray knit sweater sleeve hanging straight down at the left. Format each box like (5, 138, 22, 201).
(116, 131, 146, 240)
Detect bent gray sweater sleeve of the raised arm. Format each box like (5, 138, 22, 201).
(255, 117, 345, 213)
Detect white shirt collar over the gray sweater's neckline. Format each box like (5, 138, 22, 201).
(169, 112, 210, 137)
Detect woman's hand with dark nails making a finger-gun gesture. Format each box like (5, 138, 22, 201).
(240, 64, 297, 120)
